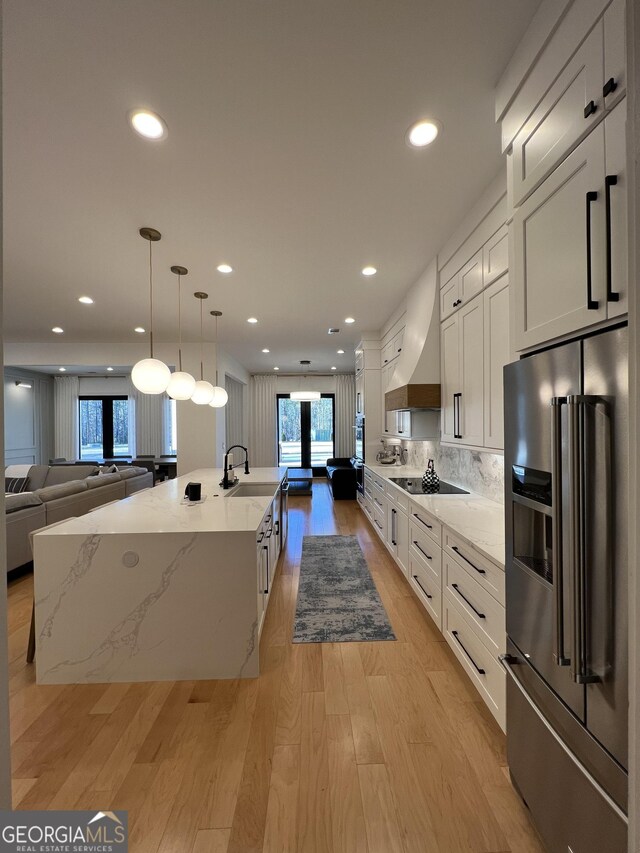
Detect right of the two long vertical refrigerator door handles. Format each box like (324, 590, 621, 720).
(567, 394, 602, 684)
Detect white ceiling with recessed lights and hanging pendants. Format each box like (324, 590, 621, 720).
(3, 0, 539, 371)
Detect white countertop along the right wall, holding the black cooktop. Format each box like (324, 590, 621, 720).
(366, 465, 505, 570)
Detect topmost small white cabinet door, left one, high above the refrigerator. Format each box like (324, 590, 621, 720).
(511, 21, 604, 205)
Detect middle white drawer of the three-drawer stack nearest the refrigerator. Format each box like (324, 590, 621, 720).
(443, 552, 506, 657)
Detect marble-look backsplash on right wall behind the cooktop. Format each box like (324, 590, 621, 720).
(403, 441, 504, 503)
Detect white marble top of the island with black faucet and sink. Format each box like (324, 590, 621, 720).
(36, 466, 287, 536)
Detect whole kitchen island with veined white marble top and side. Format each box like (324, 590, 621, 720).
(34, 468, 287, 684)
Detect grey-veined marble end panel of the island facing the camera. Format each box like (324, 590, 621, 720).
(34, 528, 260, 684)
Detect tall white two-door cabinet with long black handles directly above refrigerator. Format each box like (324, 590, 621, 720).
(513, 101, 627, 350)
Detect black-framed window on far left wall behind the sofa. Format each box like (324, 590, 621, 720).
(80, 397, 129, 460)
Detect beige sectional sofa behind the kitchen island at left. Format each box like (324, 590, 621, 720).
(5, 465, 153, 571)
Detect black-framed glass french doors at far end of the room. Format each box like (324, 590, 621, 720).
(278, 394, 335, 474)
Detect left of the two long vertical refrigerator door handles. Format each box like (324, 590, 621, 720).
(551, 397, 571, 666)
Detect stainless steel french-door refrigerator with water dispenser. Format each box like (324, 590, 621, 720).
(503, 327, 629, 853)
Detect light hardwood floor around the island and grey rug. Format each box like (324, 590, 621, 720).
(9, 481, 543, 853)
